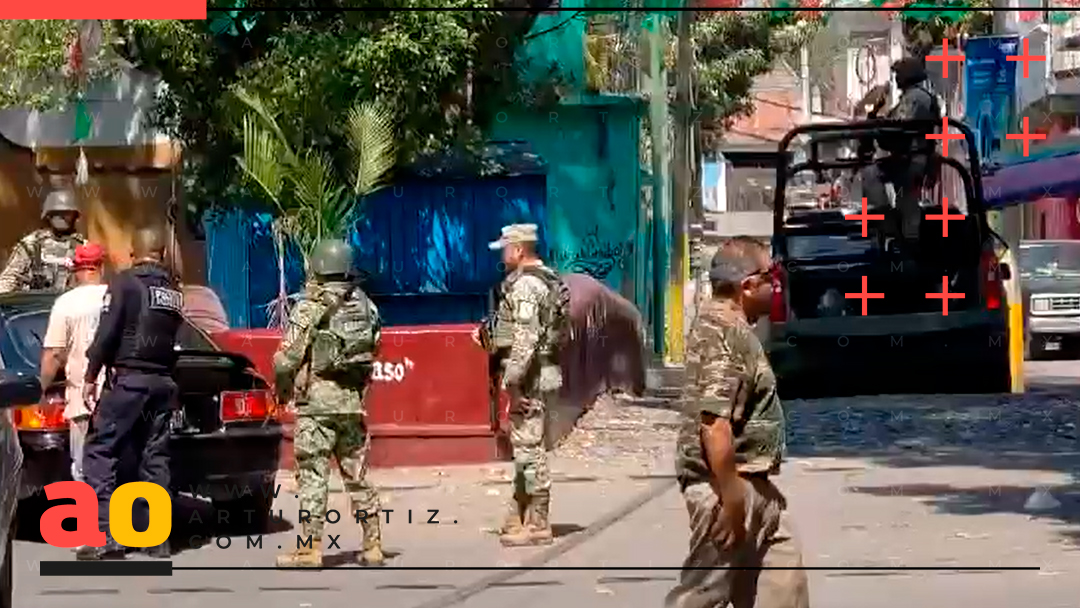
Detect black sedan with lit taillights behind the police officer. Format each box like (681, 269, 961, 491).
(0, 293, 282, 527)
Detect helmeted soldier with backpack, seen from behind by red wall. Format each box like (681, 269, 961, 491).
(273, 241, 383, 568)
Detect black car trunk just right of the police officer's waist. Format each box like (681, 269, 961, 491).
(173, 351, 265, 433)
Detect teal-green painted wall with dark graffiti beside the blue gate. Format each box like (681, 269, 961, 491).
(490, 0, 651, 311)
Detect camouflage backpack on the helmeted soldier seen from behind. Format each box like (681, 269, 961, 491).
(311, 287, 377, 379)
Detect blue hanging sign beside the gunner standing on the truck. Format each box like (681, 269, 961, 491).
(963, 36, 1021, 161)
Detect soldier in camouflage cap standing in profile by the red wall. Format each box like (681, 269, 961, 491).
(481, 224, 563, 546)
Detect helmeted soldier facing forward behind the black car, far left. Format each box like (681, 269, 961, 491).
(0, 190, 86, 294)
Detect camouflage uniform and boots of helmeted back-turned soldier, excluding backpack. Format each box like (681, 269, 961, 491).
(273, 240, 383, 567)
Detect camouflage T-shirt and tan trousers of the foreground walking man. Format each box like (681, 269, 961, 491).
(665, 299, 809, 608)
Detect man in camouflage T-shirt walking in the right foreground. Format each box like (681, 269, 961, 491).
(665, 238, 809, 608)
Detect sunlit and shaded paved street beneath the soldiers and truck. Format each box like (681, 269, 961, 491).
(8, 361, 1080, 608)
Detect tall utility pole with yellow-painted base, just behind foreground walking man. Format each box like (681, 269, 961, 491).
(666, 11, 694, 364)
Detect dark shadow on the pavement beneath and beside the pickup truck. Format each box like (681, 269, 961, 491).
(785, 387, 1080, 543)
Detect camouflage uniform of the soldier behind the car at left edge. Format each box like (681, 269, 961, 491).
(0, 228, 86, 294)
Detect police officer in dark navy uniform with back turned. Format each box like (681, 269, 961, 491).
(76, 228, 184, 559)
